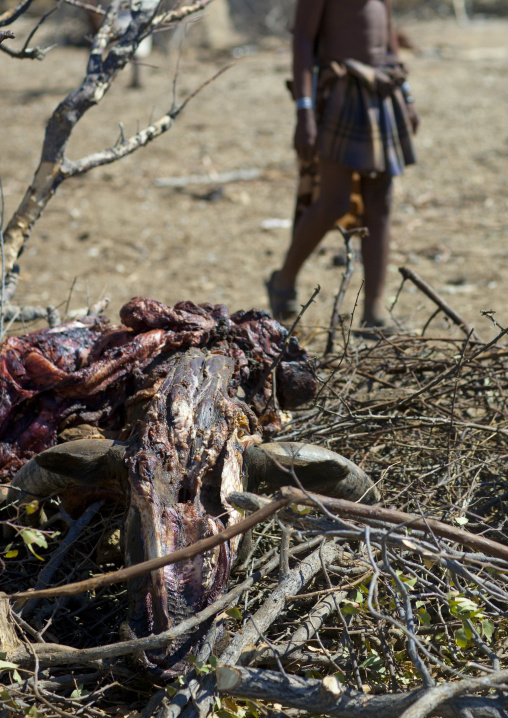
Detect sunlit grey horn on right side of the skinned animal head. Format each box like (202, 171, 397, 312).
(244, 441, 381, 504)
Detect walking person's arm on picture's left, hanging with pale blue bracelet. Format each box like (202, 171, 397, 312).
(293, 0, 326, 162)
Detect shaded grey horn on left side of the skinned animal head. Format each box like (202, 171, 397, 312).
(7, 439, 127, 503)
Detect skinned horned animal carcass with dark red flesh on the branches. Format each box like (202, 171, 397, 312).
(0, 298, 379, 675)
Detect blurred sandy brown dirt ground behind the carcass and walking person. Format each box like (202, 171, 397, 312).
(0, 14, 508, 339)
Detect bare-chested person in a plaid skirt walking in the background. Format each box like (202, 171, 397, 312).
(266, 0, 419, 327)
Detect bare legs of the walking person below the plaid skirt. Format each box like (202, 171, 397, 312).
(272, 160, 392, 324)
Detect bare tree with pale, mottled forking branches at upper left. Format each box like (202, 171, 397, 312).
(0, 0, 212, 318)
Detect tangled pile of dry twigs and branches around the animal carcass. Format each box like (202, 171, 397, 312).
(0, 320, 508, 718)
